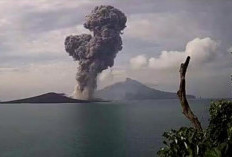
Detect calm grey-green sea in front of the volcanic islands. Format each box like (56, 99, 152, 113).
(0, 99, 210, 157)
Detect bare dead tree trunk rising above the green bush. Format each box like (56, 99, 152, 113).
(177, 56, 202, 130)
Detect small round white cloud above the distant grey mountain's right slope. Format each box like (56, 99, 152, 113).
(130, 55, 148, 69)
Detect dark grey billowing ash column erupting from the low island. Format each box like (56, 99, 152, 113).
(65, 6, 127, 99)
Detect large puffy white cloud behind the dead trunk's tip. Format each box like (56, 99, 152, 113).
(149, 38, 219, 69)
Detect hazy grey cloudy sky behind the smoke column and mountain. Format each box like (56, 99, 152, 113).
(0, 0, 232, 100)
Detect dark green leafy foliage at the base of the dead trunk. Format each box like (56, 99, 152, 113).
(157, 100, 232, 157)
